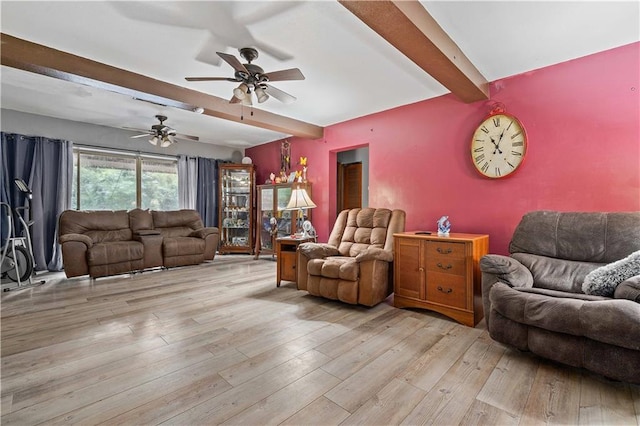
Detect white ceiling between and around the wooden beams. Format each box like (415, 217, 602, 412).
(0, 1, 640, 148)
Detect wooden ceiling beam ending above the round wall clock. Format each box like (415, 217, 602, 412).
(339, 0, 489, 103)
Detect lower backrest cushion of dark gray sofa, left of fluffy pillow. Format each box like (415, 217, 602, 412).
(511, 253, 602, 293)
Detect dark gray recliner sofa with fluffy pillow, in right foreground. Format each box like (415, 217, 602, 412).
(480, 211, 640, 383)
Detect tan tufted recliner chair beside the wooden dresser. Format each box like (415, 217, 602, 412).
(297, 207, 405, 306)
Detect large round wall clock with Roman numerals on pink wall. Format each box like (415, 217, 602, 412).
(471, 113, 527, 178)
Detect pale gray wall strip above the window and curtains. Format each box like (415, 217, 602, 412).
(0, 109, 244, 160)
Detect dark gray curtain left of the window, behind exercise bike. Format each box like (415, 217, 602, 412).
(0, 132, 73, 271)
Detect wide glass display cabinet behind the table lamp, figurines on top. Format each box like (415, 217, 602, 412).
(254, 182, 313, 259)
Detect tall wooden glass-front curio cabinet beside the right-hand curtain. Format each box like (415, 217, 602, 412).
(218, 164, 255, 254)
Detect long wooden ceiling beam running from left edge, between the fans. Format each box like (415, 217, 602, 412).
(0, 33, 324, 139)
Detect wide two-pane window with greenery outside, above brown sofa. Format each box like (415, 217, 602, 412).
(72, 148, 178, 210)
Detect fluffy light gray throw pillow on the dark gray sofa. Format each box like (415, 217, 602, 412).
(582, 250, 640, 297)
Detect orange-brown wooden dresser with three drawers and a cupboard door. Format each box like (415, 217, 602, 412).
(393, 232, 489, 327)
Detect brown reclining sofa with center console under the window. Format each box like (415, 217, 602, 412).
(58, 209, 219, 278)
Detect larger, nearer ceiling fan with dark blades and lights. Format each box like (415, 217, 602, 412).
(185, 47, 304, 105)
